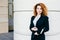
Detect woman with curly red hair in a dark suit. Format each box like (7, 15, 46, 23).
(30, 3, 49, 40)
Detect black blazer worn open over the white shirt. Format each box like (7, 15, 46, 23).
(30, 16, 49, 34)
